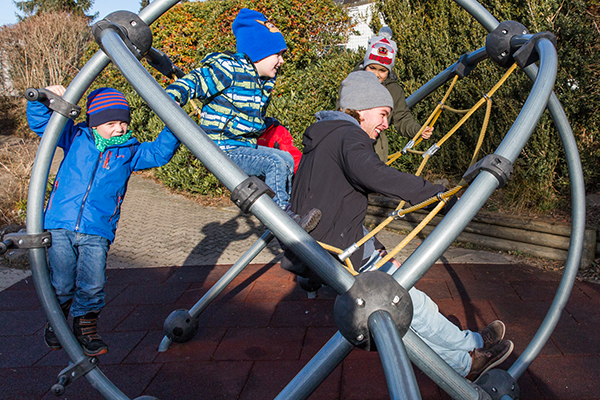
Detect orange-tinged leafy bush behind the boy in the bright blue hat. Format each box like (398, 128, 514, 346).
(87, 0, 356, 195)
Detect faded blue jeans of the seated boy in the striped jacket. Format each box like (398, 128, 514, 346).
(225, 146, 294, 210)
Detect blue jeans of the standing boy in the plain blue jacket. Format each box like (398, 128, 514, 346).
(48, 229, 110, 317)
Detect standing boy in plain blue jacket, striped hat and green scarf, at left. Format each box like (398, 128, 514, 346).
(27, 86, 180, 356)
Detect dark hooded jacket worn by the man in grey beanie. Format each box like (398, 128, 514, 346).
(282, 111, 446, 269)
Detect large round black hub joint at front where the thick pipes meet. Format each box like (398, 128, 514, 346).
(333, 271, 413, 351)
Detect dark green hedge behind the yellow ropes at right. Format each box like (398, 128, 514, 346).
(373, 0, 600, 211)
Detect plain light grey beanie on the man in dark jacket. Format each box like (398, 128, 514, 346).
(340, 71, 394, 111)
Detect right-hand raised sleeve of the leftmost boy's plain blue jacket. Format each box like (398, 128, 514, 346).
(131, 126, 181, 171)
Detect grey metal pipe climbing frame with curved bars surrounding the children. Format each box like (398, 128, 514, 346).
(22, 0, 585, 400)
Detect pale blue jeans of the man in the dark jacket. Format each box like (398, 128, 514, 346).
(360, 250, 483, 376)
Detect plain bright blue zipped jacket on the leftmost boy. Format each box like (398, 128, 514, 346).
(27, 102, 180, 243)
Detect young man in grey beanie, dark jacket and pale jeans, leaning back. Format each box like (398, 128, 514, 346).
(282, 71, 513, 380)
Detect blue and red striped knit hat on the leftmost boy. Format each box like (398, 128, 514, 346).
(87, 88, 131, 127)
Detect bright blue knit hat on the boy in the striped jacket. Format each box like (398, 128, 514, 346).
(231, 8, 287, 62)
